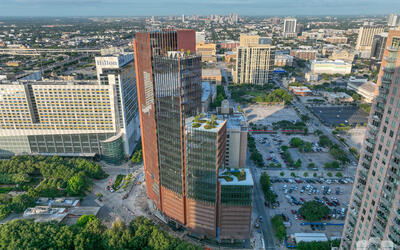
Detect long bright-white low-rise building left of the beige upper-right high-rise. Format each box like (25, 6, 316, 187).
(311, 60, 352, 75)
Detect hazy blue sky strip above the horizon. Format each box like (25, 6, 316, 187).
(0, 0, 400, 16)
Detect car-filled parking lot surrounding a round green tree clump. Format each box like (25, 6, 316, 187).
(271, 177, 353, 237)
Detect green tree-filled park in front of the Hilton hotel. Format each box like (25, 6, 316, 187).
(0, 156, 106, 219)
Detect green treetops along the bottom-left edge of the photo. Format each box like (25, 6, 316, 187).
(0, 217, 201, 250)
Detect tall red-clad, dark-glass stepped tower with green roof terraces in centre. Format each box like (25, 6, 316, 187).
(134, 30, 253, 240)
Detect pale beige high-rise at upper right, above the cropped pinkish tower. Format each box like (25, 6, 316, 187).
(356, 26, 385, 58)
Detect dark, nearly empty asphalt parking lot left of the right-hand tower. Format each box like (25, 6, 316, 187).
(312, 106, 368, 126)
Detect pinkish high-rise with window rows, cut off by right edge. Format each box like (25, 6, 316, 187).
(341, 29, 400, 249)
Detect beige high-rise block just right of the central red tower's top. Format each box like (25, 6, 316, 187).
(232, 35, 275, 85)
